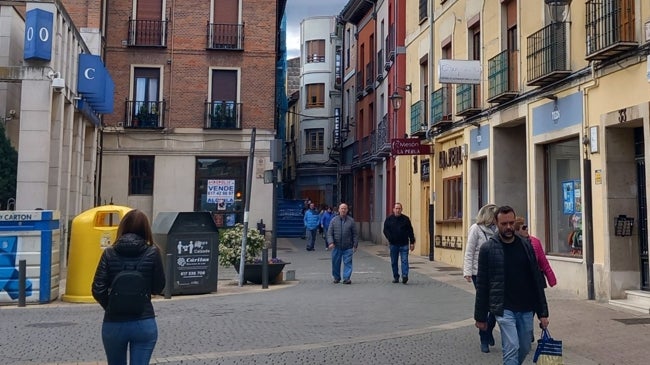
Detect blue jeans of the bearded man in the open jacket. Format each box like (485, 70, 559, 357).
(496, 309, 533, 365)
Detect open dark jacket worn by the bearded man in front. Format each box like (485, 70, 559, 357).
(474, 234, 548, 322)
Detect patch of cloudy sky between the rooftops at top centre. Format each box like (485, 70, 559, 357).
(286, 0, 348, 58)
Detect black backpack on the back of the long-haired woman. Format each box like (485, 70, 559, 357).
(106, 250, 151, 316)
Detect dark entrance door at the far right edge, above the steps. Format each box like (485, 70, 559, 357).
(634, 128, 650, 291)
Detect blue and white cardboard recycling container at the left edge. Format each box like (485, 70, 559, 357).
(0, 210, 61, 304)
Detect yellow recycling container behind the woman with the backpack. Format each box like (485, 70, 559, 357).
(61, 205, 132, 303)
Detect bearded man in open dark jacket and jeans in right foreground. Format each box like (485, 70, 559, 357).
(474, 205, 548, 365)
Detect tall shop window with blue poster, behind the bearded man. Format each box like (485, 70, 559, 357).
(545, 138, 582, 256)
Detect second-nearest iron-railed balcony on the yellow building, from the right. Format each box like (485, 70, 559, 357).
(526, 22, 571, 86)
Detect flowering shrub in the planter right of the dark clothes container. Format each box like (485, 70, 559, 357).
(219, 223, 266, 266)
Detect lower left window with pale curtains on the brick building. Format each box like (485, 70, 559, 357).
(129, 67, 163, 128)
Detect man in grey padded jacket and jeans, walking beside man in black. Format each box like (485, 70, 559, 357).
(327, 203, 359, 284)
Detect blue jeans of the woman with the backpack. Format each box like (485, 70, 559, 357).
(102, 318, 158, 365)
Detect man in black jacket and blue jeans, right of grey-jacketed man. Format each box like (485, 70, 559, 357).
(384, 203, 415, 284)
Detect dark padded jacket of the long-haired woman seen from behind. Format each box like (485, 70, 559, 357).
(92, 233, 165, 322)
